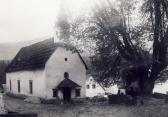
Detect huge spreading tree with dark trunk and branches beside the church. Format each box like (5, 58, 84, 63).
(74, 0, 168, 95)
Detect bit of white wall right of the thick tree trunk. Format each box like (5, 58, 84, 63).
(153, 81, 168, 94)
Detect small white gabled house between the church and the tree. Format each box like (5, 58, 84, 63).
(86, 76, 118, 97)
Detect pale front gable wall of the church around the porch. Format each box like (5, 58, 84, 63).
(45, 47, 86, 98)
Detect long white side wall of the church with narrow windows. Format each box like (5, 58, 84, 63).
(6, 70, 46, 98)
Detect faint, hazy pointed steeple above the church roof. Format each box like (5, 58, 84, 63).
(55, 0, 70, 43)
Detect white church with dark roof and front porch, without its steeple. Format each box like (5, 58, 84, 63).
(6, 39, 87, 101)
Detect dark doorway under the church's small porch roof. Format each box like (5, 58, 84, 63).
(63, 87, 71, 102)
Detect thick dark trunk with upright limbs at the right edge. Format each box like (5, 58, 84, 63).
(139, 0, 168, 94)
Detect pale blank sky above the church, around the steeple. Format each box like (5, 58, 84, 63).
(0, 0, 98, 43)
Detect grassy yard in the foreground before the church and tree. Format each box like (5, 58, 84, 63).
(2, 97, 168, 117)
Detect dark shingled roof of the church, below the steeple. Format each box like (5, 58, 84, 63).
(6, 38, 87, 72)
